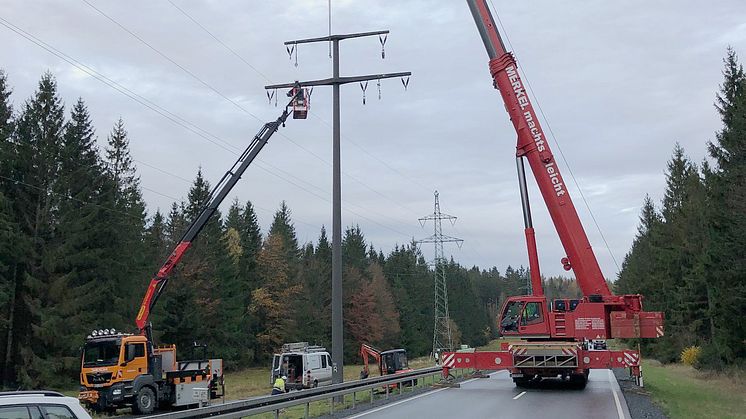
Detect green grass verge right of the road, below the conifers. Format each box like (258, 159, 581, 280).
(643, 361, 746, 418)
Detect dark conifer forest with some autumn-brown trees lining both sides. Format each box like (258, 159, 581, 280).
(0, 46, 746, 388)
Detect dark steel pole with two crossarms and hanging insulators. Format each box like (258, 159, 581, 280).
(264, 30, 412, 383)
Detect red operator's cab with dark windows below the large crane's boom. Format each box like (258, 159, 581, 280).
(500, 296, 550, 338)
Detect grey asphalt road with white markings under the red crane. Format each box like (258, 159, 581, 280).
(342, 370, 630, 419)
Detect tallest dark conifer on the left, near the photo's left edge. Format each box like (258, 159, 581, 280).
(8, 73, 64, 387)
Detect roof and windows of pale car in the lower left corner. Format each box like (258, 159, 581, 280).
(0, 391, 91, 419)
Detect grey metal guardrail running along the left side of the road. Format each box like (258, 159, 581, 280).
(147, 367, 442, 419)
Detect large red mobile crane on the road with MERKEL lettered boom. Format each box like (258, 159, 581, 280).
(441, 0, 663, 387)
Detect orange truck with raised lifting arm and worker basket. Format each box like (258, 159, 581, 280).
(78, 84, 308, 414)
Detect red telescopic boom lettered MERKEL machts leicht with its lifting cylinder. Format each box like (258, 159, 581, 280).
(467, 0, 611, 296)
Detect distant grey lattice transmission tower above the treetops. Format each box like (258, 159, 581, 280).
(417, 191, 464, 360)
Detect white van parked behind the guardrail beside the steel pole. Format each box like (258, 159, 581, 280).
(269, 342, 332, 391)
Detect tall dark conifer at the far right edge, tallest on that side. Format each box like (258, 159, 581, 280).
(703, 48, 746, 368)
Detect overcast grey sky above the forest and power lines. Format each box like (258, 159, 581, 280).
(0, 0, 746, 279)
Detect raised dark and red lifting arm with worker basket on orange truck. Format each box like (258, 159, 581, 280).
(135, 86, 307, 342)
